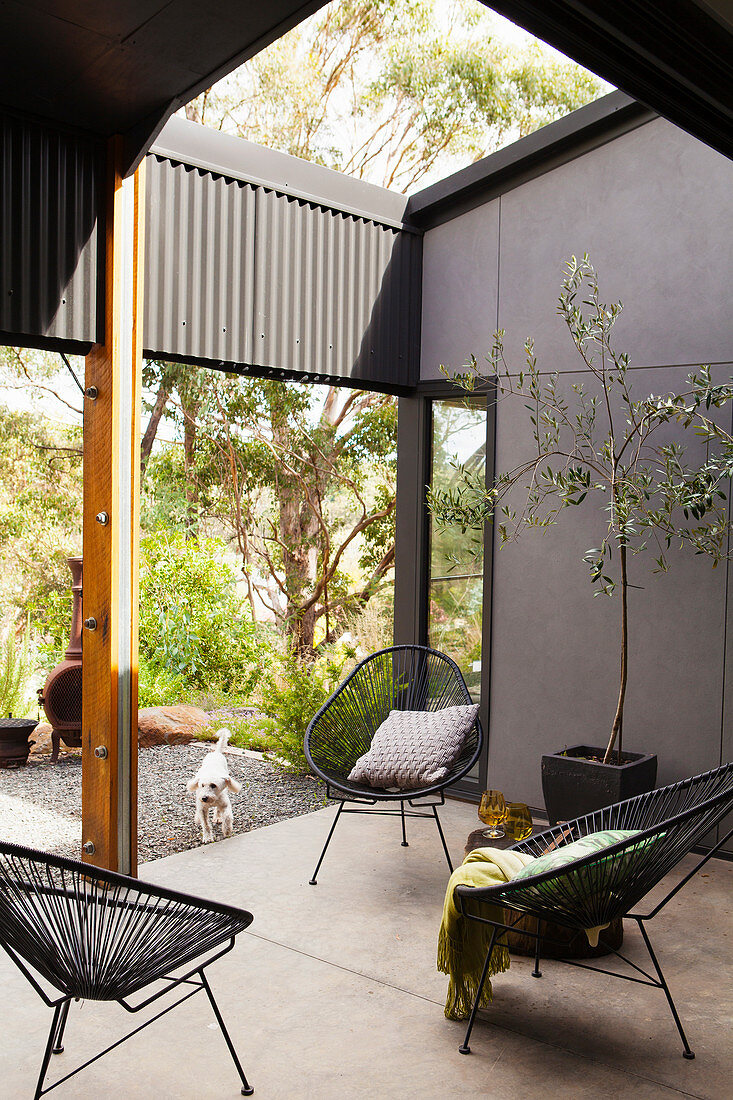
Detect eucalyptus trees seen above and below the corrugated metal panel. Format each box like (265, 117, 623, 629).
(143, 0, 604, 653)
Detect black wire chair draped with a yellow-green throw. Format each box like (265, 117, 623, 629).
(456, 763, 733, 1058)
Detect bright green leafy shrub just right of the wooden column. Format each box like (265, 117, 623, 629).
(140, 530, 269, 706)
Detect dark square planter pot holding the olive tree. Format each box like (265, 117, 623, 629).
(543, 745, 657, 825)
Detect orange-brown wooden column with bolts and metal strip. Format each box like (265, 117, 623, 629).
(81, 138, 144, 875)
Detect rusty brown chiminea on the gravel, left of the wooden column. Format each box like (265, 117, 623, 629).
(39, 558, 83, 761)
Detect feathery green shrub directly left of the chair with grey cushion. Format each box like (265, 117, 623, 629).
(260, 645, 357, 772)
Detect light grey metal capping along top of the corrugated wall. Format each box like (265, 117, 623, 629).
(150, 118, 415, 232)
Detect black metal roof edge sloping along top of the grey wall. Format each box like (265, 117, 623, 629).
(406, 91, 658, 230)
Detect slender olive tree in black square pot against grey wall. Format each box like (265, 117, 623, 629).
(428, 255, 733, 821)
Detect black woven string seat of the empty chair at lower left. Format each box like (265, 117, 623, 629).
(0, 843, 252, 1001)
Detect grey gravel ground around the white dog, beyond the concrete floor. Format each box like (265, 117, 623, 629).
(0, 744, 326, 864)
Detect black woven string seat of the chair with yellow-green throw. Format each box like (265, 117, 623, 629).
(457, 763, 733, 928)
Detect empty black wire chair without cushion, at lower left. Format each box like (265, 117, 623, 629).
(0, 842, 254, 1100)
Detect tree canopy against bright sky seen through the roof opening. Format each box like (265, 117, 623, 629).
(186, 0, 609, 191)
